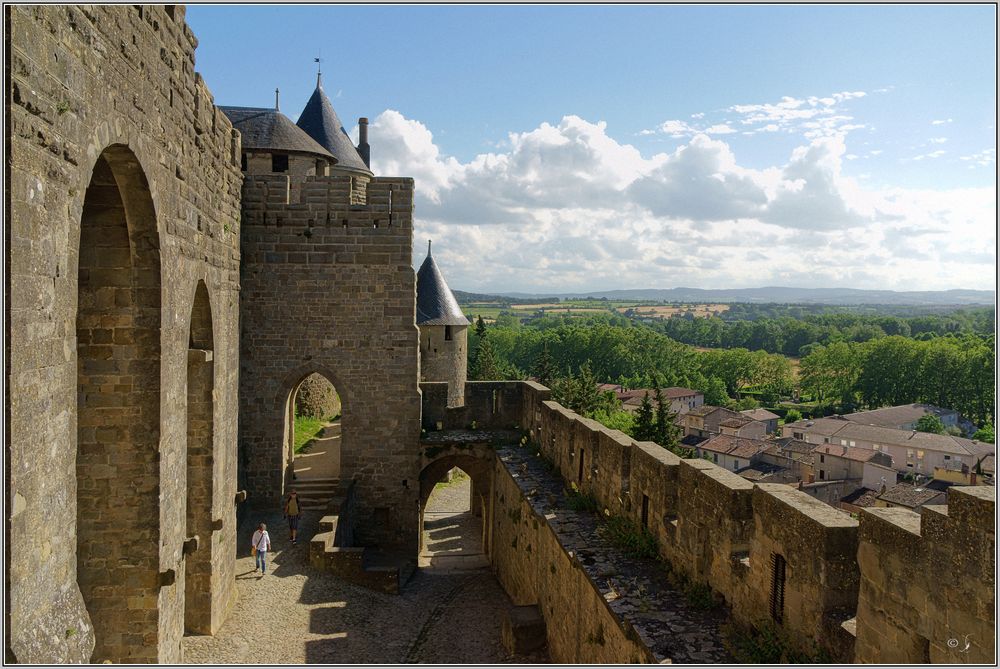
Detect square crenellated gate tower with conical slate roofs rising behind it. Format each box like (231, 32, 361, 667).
(222, 74, 420, 553)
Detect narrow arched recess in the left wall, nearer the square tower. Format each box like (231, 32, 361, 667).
(184, 281, 215, 634)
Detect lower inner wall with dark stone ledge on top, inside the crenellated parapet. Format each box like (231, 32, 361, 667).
(488, 447, 732, 664)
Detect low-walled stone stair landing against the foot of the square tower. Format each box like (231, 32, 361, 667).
(299, 482, 416, 595)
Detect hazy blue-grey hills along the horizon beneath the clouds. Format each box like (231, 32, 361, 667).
(454, 286, 996, 305)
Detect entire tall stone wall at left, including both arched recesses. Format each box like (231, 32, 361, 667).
(4, 5, 241, 663)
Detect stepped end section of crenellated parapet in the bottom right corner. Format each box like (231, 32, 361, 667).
(855, 486, 996, 664)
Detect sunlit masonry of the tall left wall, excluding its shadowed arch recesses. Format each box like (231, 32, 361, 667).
(4, 5, 241, 663)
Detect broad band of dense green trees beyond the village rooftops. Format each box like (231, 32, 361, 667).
(469, 315, 996, 431)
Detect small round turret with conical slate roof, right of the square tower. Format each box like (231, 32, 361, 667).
(417, 242, 469, 407)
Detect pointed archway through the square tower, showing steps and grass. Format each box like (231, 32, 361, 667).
(283, 371, 345, 510)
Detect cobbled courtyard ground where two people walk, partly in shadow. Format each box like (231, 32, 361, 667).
(184, 480, 545, 664)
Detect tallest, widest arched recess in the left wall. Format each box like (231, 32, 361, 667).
(76, 144, 160, 662)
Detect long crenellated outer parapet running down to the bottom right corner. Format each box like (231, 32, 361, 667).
(424, 382, 995, 663)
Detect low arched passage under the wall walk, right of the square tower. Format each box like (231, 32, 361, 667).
(417, 455, 492, 571)
